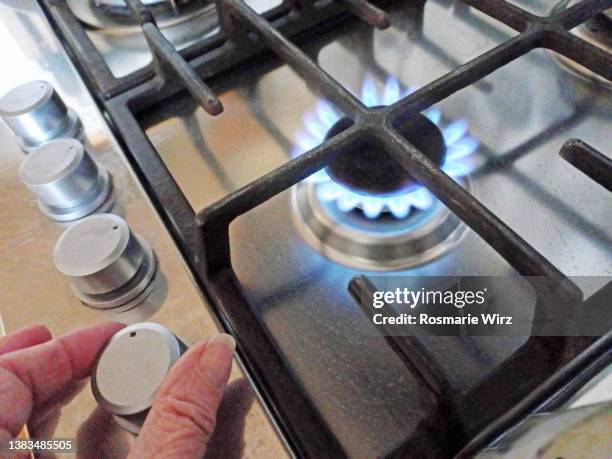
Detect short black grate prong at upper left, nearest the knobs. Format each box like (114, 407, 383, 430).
(127, 0, 223, 116)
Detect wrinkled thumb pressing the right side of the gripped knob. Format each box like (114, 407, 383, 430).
(129, 334, 236, 459)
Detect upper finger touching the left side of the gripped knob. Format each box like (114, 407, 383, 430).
(0, 323, 123, 436)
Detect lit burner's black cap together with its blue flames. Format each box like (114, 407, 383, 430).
(293, 77, 478, 219)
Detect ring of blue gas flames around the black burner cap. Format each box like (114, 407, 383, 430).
(293, 75, 478, 219)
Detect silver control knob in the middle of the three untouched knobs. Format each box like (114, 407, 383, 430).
(19, 139, 111, 221)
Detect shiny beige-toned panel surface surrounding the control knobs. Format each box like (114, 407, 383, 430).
(0, 1, 287, 458)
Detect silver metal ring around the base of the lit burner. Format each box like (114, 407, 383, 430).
(291, 179, 472, 271)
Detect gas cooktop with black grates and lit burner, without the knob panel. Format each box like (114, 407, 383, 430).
(9, 0, 612, 457)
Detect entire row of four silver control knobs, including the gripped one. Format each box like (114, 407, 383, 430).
(0, 81, 179, 433)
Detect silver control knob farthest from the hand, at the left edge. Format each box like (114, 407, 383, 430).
(0, 80, 82, 152)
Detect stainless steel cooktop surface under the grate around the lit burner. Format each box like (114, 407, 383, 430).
(135, 1, 612, 457)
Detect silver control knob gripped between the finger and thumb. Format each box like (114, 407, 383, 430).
(91, 322, 187, 433)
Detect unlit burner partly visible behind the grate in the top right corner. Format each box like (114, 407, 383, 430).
(552, 0, 612, 88)
